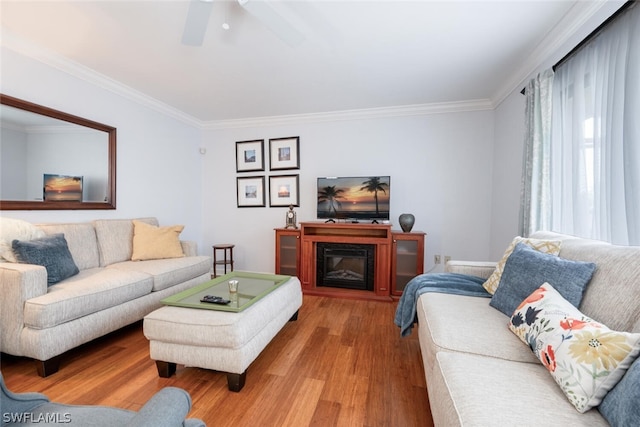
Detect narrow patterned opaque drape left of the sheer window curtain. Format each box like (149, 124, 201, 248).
(520, 69, 553, 237)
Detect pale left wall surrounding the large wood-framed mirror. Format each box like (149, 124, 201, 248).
(0, 47, 202, 246)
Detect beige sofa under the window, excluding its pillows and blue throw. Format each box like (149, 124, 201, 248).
(417, 232, 640, 427)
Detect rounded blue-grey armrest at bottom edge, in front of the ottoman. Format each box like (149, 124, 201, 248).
(127, 387, 204, 427)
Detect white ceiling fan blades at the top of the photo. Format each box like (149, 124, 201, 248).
(182, 0, 305, 46)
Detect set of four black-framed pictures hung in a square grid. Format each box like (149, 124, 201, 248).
(236, 136, 300, 208)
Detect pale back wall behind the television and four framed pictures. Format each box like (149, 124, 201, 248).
(202, 111, 493, 271)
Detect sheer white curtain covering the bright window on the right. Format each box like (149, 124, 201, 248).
(548, 6, 640, 245)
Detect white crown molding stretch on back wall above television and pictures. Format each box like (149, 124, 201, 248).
(203, 99, 495, 130)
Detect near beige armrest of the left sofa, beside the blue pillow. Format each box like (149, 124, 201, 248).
(0, 262, 47, 356)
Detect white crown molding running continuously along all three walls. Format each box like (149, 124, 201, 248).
(0, 0, 624, 130)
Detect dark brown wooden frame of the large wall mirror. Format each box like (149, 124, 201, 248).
(0, 94, 116, 210)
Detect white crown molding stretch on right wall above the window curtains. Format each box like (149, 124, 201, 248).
(492, 0, 625, 107)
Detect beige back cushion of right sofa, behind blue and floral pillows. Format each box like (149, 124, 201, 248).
(532, 231, 640, 332)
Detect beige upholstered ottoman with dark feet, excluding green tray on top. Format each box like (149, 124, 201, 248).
(143, 277, 302, 392)
